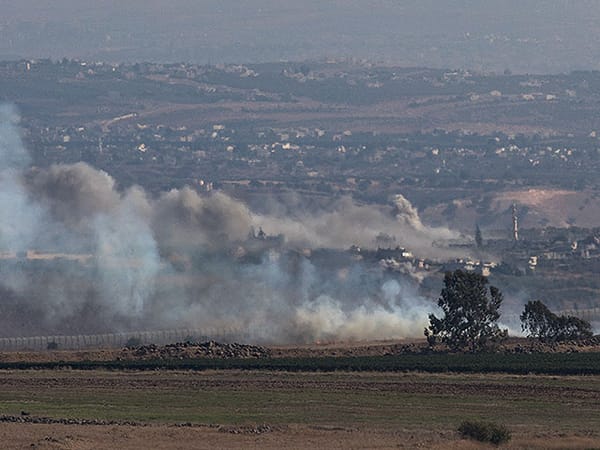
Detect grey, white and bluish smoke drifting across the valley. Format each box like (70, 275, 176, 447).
(0, 106, 452, 342)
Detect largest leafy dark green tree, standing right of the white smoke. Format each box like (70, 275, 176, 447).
(425, 270, 508, 353)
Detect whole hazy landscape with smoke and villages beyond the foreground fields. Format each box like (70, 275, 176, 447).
(0, 0, 600, 342)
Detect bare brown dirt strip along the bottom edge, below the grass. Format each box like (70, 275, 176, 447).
(7, 424, 599, 450)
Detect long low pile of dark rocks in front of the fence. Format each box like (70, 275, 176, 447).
(120, 341, 271, 359)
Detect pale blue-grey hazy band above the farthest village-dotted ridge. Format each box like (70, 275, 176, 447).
(0, 0, 600, 72)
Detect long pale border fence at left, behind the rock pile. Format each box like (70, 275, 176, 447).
(0, 328, 251, 351)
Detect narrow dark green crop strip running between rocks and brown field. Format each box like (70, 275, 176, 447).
(0, 353, 600, 375)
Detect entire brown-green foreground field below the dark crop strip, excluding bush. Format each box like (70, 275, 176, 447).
(0, 370, 600, 449)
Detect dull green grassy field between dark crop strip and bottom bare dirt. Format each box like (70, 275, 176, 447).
(0, 371, 600, 434)
